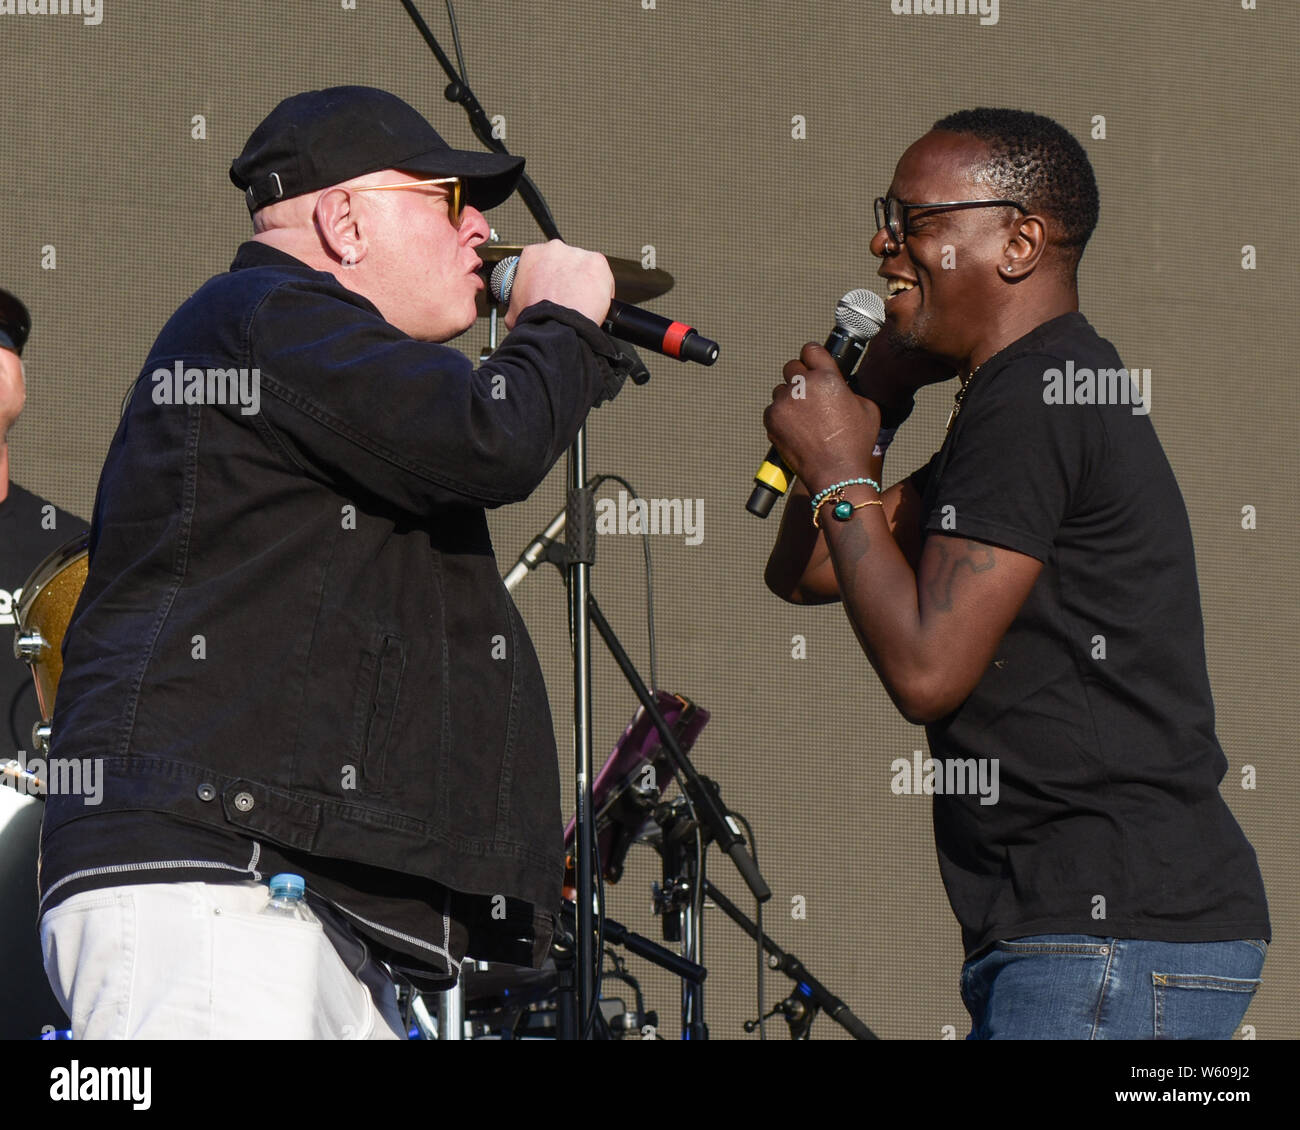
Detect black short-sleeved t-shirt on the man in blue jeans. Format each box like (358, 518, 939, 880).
(915, 313, 1270, 957)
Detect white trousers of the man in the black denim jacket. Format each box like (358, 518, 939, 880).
(40, 880, 404, 1040)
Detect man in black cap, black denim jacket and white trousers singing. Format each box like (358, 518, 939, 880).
(40, 87, 633, 1039)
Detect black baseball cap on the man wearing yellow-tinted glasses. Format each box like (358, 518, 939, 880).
(230, 86, 524, 212)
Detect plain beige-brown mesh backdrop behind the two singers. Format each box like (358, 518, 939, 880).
(0, 0, 1300, 1039)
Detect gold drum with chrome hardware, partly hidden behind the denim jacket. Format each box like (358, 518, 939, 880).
(13, 531, 90, 757)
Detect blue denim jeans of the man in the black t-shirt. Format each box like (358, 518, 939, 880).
(962, 934, 1268, 1040)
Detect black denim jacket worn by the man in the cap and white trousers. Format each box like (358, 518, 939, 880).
(44, 243, 633, 908)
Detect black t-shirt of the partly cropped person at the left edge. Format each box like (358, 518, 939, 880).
(0, 482, 87, 761)
